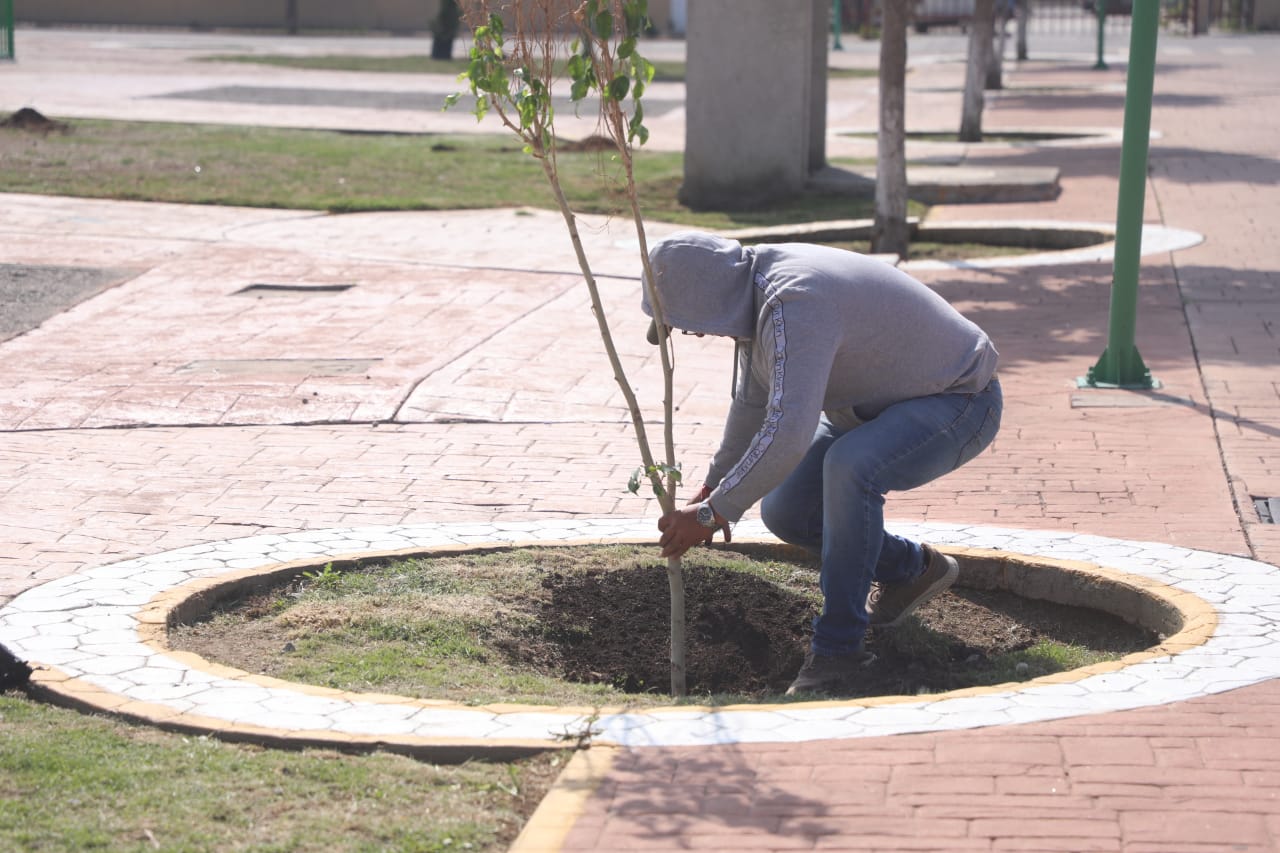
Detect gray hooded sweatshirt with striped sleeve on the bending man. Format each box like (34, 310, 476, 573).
(641, 232, 998, 521)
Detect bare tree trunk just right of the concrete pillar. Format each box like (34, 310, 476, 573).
(872, 3, 910, 257)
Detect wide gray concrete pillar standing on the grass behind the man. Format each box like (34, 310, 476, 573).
(680, 0, 831, 209)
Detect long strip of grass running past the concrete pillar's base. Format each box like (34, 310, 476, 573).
(0, 120, 890, 228)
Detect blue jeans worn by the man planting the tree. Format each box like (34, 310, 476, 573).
(760, 379, 1004, 654)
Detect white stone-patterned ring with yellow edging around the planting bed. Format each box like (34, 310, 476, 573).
(0, 519, 1280, 760)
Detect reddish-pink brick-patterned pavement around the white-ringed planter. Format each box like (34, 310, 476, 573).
(0, 23, 1280, 853)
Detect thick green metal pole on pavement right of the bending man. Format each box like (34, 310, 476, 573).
(1079, 0, 1160, 388)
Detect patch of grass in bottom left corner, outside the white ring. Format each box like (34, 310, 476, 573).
(0, 693, 564, 853)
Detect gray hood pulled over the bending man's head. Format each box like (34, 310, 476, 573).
(640, 231, 755, 343)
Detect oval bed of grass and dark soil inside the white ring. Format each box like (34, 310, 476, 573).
(169, 543, 1181, 707)
